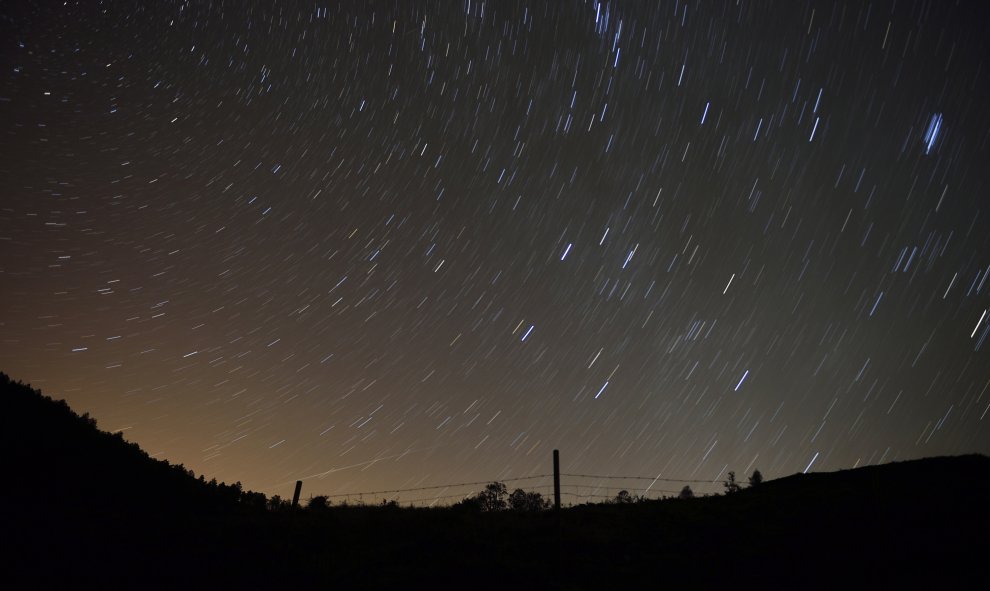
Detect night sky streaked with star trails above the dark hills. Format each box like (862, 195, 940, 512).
(0, 0, 990, 502)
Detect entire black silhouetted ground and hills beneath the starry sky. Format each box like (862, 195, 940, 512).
(0, 374, 990, 589)
